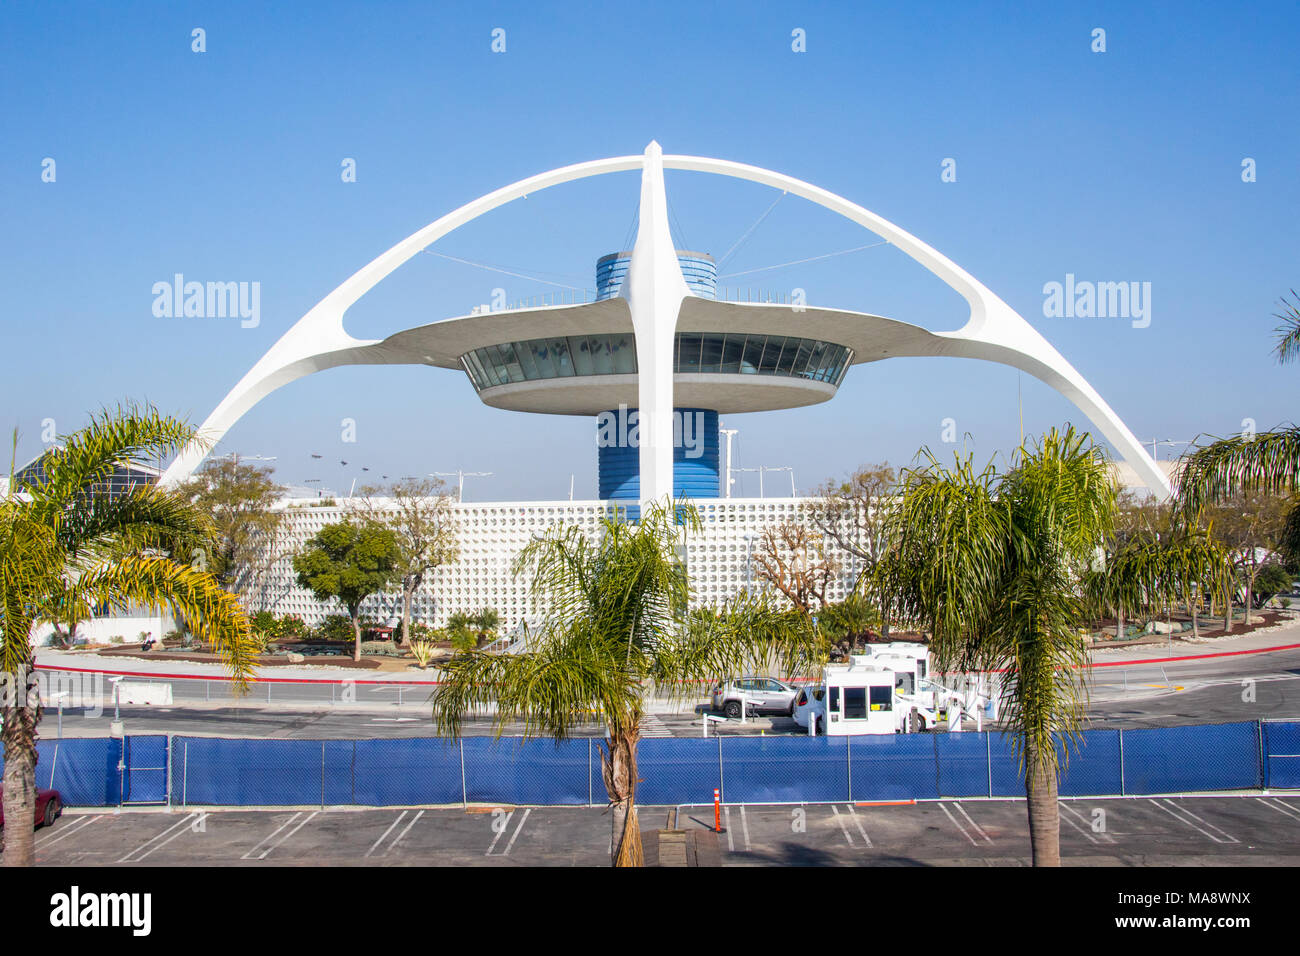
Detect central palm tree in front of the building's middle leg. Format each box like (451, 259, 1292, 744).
(434, 502, 815, 866)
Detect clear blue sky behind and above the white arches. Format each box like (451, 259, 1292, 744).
(0, 3, 1300, 499)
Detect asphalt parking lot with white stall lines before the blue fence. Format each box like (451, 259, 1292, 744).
(25, 795, 1300, 866)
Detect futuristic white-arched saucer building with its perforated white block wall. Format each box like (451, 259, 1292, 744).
(152, 143, 1169, 627)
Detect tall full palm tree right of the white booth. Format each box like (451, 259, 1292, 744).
(876, 428, 1118, 866)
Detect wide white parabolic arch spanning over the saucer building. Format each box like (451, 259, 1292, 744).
(161, 143, 1170, 496)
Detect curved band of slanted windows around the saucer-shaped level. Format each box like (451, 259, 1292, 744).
(460, 332, 853, 392)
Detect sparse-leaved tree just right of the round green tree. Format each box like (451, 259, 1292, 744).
(361, 479, 459, 644)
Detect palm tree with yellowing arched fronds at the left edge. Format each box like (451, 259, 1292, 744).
(0, 406, 255, 866)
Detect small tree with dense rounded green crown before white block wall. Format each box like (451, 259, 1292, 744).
(294, 522, 402, 661)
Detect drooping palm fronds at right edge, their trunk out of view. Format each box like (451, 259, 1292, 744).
(1177, 290, 1300, 548)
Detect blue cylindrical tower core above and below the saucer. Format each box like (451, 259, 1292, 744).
(595, 250, 720, 501)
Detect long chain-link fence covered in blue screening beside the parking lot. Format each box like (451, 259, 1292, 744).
(17, 721, 1300, 806)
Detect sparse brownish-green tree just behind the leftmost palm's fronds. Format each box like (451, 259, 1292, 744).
(179, 455, 285, 610)
